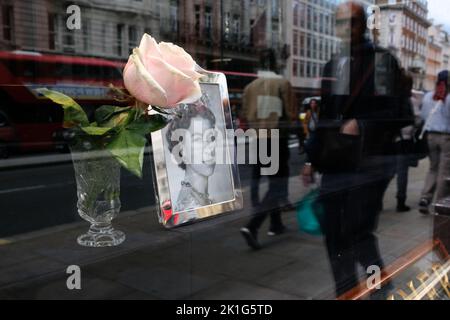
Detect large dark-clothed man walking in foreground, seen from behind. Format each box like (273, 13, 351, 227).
(304, 2, 410, 295)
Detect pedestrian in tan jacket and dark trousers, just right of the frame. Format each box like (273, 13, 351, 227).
(241, 50, 294, 249)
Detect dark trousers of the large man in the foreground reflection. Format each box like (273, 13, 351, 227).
(318, 169, 385, 296)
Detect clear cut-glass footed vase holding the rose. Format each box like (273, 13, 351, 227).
(72, 150, 125, 247)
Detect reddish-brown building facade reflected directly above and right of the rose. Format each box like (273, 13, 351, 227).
(178, 0, 266, 71)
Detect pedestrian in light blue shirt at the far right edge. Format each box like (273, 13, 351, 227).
(419, 71, 450, 214)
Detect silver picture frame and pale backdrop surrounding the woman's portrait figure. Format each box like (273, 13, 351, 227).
(151, 68, 243, 229)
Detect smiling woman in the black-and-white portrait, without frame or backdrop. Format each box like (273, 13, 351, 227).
(167, 102, 216, 223)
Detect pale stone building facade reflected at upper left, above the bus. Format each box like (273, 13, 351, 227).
(1, 0, 160, 59)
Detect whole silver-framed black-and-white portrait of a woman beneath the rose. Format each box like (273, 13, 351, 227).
(152, 71, 243, 228)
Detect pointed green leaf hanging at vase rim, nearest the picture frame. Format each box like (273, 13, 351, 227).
(107, 129, 147, 178)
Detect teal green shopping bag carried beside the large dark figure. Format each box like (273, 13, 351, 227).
(297, 189, 323, 236)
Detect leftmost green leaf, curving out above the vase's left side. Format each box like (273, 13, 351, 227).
(36, 88, 89, 128)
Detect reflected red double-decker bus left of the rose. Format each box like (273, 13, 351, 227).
(0, 51, 124, 156)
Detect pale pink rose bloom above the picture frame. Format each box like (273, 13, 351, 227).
(123, 34, 202, 108)
